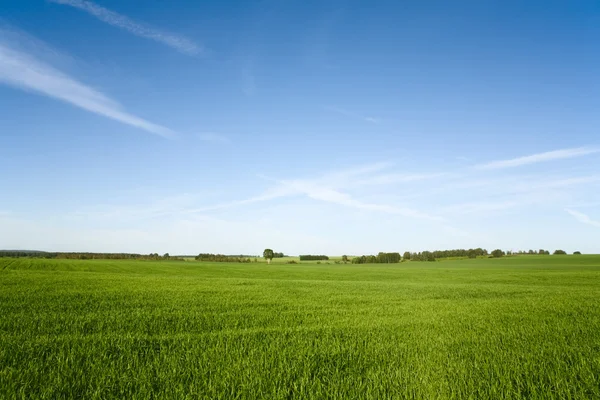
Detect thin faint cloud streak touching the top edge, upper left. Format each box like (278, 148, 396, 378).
(48, 0, 203, 55)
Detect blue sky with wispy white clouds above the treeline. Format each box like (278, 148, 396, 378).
(0, 0, 600, 255)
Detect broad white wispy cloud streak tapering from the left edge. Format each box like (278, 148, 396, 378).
(0, 30, 176, 137)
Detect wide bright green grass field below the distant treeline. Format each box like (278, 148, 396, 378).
(0, 256, 600, 399)
